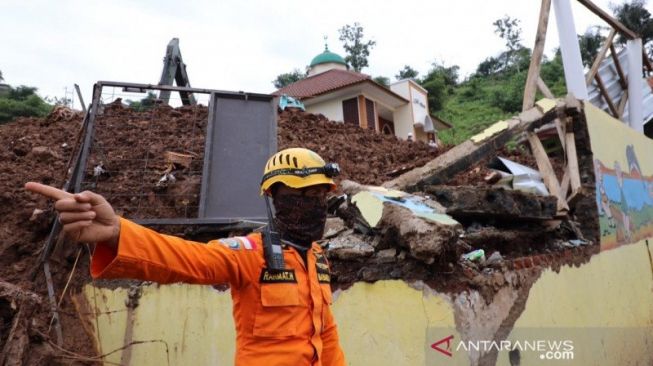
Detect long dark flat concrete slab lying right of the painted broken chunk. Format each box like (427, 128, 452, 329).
(425, 186, 557, 220)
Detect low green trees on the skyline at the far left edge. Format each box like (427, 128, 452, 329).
(0, 85, 52, 124)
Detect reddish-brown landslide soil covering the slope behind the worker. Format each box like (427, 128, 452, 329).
(0, 101, 439, 364)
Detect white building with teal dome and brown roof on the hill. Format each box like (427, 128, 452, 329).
(273, 48, 452, 142)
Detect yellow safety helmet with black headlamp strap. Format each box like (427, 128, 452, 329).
(261, 147, 340, 194)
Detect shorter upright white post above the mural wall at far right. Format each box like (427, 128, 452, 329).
(626, 38, 644, 133)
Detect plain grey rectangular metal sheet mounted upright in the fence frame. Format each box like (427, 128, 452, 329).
(199, 93, 277, 221)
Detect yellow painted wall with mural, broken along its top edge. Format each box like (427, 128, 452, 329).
(83, 101, 653, 366)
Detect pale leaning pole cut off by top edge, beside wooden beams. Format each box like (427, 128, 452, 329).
(553, 0, 589, 100)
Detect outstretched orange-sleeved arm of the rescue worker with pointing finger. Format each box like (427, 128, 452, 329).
(25, 182, 251, 286)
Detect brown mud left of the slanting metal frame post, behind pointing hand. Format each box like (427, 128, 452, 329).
(0, 109, 94, 365)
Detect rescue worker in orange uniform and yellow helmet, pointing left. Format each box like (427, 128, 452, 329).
(25, 148, 345, 366)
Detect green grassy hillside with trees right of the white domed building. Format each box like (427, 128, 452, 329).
(422, 16, 564, 145)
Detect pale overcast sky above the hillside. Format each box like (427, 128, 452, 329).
(0, 0, 653, 108)
